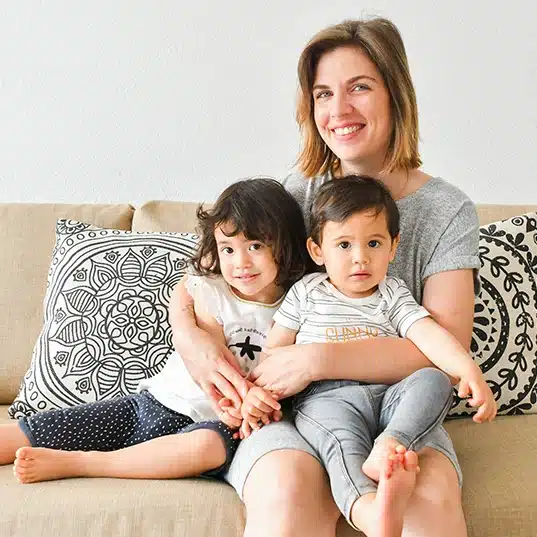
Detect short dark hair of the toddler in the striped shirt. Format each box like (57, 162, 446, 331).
(310, 175, 399, 245)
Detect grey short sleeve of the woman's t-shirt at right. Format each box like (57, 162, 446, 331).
(422, 200, 480, 280)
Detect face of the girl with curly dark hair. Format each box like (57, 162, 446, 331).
(214, 224, 284, 304)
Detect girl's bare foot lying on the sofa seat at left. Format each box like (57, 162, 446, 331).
(13, 447, 88, 483)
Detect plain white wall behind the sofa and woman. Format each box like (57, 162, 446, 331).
(0, 0, 537, 204)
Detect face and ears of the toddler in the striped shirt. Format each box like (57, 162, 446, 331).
(308, 210, 398, 298)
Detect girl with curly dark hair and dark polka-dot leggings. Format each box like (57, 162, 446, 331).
(4, 178, 309, 483)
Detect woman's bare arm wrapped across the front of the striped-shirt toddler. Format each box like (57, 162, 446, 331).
(254, 269, 474, 397)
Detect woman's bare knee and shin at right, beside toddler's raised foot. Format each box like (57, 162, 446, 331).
(403, 448, 468, 537)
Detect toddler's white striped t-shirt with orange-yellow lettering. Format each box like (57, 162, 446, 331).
(274, 273, 429, 343)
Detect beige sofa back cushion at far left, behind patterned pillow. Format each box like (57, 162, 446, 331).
(0, 203, 134, 404)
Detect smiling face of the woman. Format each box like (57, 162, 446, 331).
(313, 47, 392, 175)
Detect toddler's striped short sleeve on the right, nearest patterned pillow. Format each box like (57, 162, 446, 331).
(379, 278, 429, 337)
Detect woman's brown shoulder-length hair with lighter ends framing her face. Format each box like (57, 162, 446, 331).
(296, 18, 421, 177)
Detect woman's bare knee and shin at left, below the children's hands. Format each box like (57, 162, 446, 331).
(244, 449, 340, 537)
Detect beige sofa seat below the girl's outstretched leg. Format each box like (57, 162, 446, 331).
(0, 466, 244, 537)
